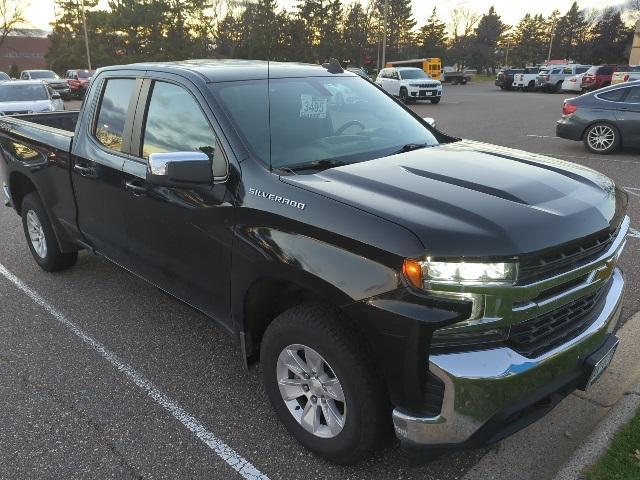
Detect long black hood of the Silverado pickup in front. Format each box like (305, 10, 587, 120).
(282, 141, 626, 257)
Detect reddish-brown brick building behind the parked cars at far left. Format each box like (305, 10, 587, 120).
(0, 30, 51, 72)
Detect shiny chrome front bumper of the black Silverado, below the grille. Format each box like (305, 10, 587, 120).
(393, 269, 624, 446)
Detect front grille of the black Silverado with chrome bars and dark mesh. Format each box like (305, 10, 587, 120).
(431, 217, 629, 358)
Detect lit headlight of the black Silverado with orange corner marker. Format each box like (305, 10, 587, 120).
(403, 258, 518, 289)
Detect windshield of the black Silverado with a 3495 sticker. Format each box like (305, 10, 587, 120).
(211, 76, 438, 168)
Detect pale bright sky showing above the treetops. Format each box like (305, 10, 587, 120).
(26, 0, 625, 29)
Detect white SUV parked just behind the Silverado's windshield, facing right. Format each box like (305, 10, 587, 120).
(376, 67, 442, 103)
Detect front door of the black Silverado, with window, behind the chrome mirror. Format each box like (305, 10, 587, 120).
(119, 76, 237, 321)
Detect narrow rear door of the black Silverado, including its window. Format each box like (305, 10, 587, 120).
(71, 77, 141, 266)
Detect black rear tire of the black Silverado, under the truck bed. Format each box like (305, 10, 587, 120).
(20, 192, 78, 272)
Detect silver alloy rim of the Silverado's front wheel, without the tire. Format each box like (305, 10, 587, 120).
(276, 344, 347, 438)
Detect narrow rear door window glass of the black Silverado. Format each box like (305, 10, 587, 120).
(94, 78, 135, 152)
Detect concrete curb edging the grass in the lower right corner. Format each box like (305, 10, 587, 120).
(553, 383, 640, 480)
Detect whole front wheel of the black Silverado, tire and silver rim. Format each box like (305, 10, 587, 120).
(260, 304, 391, 464)
